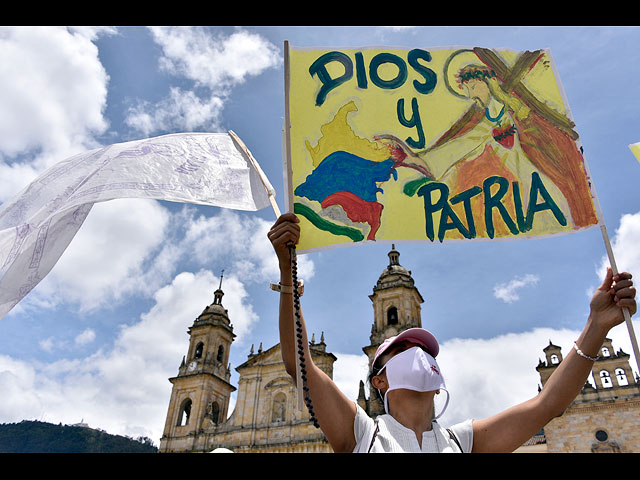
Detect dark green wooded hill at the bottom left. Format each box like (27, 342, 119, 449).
(0, 420, 158, 453)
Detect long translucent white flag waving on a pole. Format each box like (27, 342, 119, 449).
(0, 132, 275, 318)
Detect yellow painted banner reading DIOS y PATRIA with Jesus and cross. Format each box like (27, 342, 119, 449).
(285, 47, 601, 252)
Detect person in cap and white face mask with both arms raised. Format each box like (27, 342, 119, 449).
(268, 213, 637, 453)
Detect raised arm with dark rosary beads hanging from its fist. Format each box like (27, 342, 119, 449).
(268, 213, 356, 453)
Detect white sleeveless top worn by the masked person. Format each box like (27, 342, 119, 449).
(353, 404, 473, 453)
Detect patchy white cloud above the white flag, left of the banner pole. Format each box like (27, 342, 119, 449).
(126, 27, 280, 135)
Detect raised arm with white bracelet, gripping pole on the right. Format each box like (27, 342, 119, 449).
(473, 269, 637, 452)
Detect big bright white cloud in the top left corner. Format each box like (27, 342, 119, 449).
(0, 27, 109, 164)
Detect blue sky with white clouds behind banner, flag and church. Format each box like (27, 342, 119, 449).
(0, 26, 640, 445)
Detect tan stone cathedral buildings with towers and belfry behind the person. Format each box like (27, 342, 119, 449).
(159, 246, 640, 453)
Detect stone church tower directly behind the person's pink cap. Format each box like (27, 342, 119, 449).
(358, 245, 424, 417)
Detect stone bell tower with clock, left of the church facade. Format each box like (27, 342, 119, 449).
(159, 271, 235, 452)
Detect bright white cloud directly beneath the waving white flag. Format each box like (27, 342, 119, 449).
(22, 199, 172, 311)
